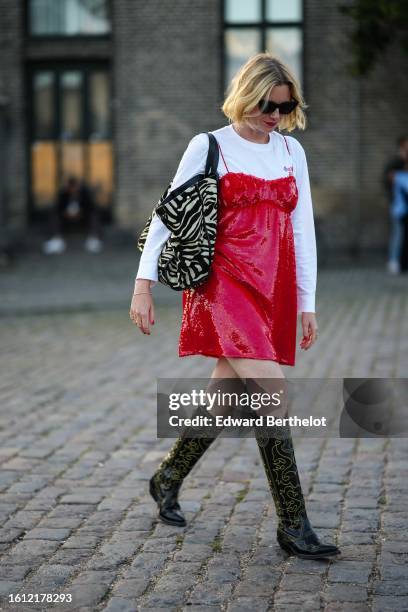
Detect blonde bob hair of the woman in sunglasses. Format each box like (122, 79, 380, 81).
(221, 52, 308, 132)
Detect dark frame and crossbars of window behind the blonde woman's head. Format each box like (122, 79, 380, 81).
(220, 0, 306, 94)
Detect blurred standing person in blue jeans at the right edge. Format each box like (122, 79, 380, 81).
(383, 136, 408, 274)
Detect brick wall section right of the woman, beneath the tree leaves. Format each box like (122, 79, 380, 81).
(297, 0, 408, 249)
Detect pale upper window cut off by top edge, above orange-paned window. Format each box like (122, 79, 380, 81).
(28, 0, 111, 36)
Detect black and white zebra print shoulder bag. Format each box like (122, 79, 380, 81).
(137, 132, 219, 291)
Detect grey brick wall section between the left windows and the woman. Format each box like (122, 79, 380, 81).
(114, 0, 223, 230)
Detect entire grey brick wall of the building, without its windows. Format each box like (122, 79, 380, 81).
(0, 0, 408, 249)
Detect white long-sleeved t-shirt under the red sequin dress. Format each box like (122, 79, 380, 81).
(136, 124, 317, 314)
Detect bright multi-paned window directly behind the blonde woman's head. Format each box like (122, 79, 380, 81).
(224, 0, 303, 89)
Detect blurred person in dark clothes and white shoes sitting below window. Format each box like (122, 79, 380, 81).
(43, 176, 103, 255)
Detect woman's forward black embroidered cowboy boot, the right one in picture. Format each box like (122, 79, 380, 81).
(255, 426, 341, 559)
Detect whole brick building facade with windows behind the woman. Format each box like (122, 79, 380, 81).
(0, 0, 408, 251)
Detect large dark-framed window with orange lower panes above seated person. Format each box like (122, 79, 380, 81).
(29, 63, 114, 213)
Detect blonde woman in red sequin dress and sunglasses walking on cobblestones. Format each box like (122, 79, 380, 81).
(130, 53, 340, 559)
